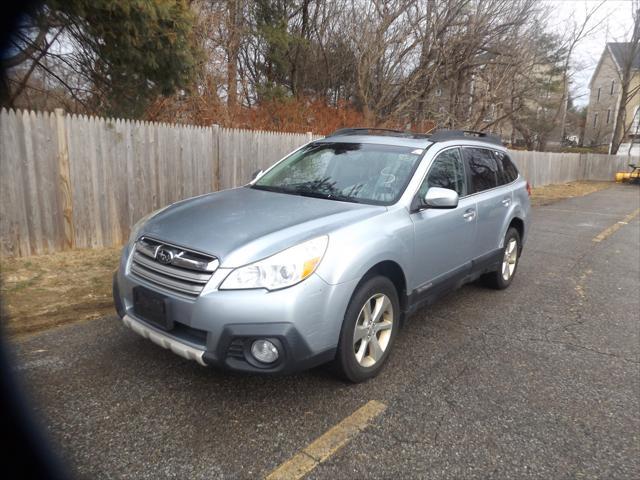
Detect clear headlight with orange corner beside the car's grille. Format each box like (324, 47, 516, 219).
(220, 236, 329, 290)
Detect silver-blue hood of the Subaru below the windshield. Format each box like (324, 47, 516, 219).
(140, 187, 386, 267)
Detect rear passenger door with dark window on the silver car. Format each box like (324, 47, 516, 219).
(463, 147, 513, 261)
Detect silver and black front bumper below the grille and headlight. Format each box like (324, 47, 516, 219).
(113, 252, 356, 373)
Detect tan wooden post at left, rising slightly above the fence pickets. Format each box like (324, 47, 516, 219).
(55, 108, 76, 249)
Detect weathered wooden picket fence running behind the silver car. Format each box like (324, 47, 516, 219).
(0, 109, 627, 256)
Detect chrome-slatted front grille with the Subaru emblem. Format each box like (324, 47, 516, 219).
(131, 237, 219, 298)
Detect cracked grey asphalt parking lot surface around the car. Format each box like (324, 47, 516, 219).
(6, 185, 640, 479)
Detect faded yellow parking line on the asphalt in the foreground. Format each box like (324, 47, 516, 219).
(266, 400, 387, 480)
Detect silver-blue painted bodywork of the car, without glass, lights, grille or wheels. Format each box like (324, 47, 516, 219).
(118, 136, 530, 370)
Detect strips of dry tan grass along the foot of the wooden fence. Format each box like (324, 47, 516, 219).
(0, 182, 611, 337)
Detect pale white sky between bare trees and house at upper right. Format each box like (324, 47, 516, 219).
(547, 0, 633, 105)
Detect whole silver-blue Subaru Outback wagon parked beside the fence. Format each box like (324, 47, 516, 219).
(113, 129, 530, 382)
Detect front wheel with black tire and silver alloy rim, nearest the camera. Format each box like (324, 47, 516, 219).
(334, 276, 400, 383)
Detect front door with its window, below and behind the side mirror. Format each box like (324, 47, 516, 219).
(411, 147, 477, 294)
